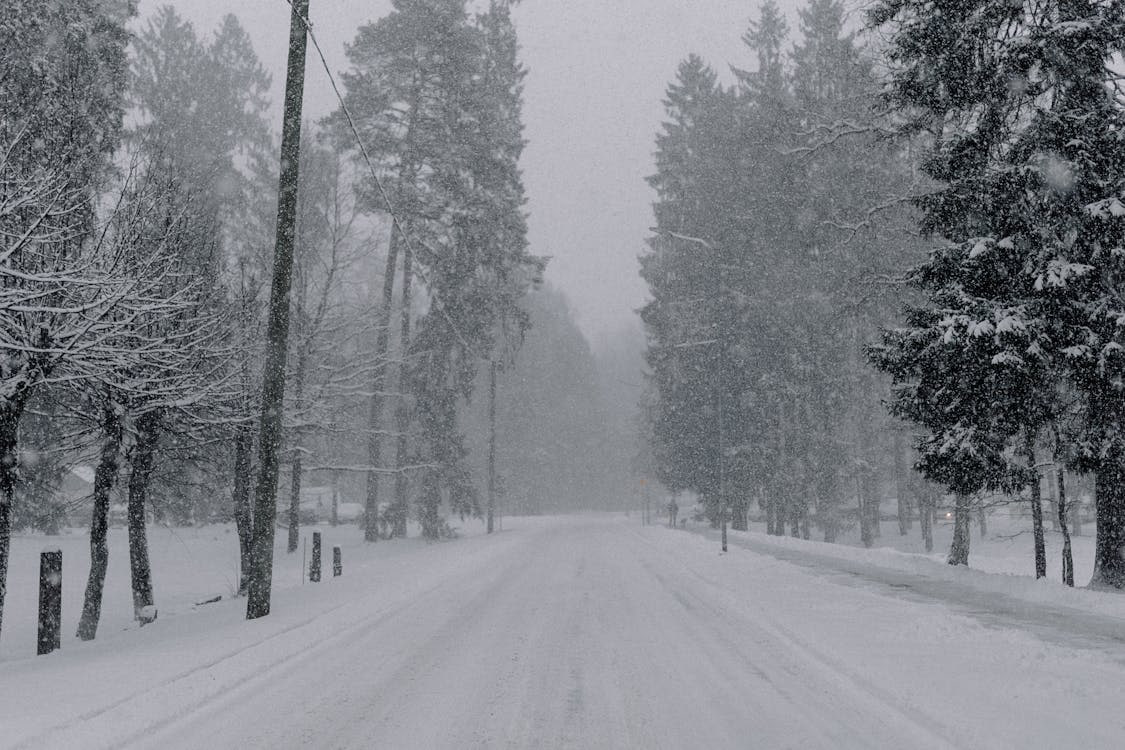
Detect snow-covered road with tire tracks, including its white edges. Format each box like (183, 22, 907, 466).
(0, 517, 1125, 749)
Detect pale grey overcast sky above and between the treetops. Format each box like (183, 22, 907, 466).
(140, 0, 794, 337)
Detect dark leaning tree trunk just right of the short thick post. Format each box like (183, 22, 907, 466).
(78, 404, 125, 641)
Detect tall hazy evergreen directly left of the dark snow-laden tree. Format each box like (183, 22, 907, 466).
(786, 0, 912, 545)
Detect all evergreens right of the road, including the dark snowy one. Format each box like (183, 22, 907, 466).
(642, 0, 1125, 588)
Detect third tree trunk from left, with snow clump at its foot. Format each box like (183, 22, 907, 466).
(128, 412, 161, 625)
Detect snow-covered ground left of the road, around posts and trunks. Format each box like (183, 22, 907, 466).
(0, 522, 505, 748)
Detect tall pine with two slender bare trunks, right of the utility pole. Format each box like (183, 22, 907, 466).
(333, 0, 478, 541)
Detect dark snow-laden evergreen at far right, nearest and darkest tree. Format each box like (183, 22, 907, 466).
(871, 0, 1125, 587)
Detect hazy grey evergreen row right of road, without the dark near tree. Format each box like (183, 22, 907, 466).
(641, 0, 918, 544)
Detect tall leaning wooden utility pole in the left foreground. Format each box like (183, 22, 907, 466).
(246, 0, 308, 620)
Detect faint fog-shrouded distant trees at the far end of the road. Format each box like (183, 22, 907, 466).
(465, 287, 641, 515)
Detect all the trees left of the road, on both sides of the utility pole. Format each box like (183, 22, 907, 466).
(0, 0, 543, 639)
